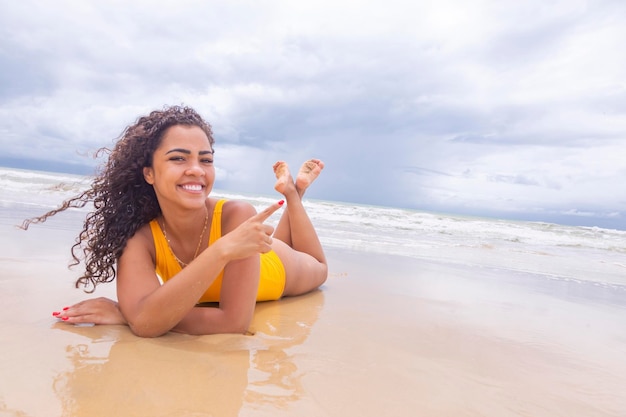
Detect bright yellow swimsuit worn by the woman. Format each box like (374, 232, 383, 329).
(150, 200, 285, 303)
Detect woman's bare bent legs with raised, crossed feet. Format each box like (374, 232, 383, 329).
(274, 159, 328, 295)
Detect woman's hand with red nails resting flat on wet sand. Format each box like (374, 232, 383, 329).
(52, 297, 127, 324)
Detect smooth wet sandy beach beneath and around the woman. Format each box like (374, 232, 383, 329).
(0, 206, 626, 417)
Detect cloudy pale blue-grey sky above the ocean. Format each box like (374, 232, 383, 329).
(0, 0, 626, 230)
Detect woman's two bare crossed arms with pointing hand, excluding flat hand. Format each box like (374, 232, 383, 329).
(117, 203, 280, 337)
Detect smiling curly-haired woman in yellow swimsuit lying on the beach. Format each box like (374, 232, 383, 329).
(23, 106, 328, 337)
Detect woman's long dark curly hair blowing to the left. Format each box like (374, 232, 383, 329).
(22, 106, 215, 293)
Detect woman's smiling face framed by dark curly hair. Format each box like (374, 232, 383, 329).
(143, 125, 215, 209)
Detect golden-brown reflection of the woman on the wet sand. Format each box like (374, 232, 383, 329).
(53, 291, 324, 416)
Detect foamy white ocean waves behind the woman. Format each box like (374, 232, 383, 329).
(0, 167, 626, 293)
